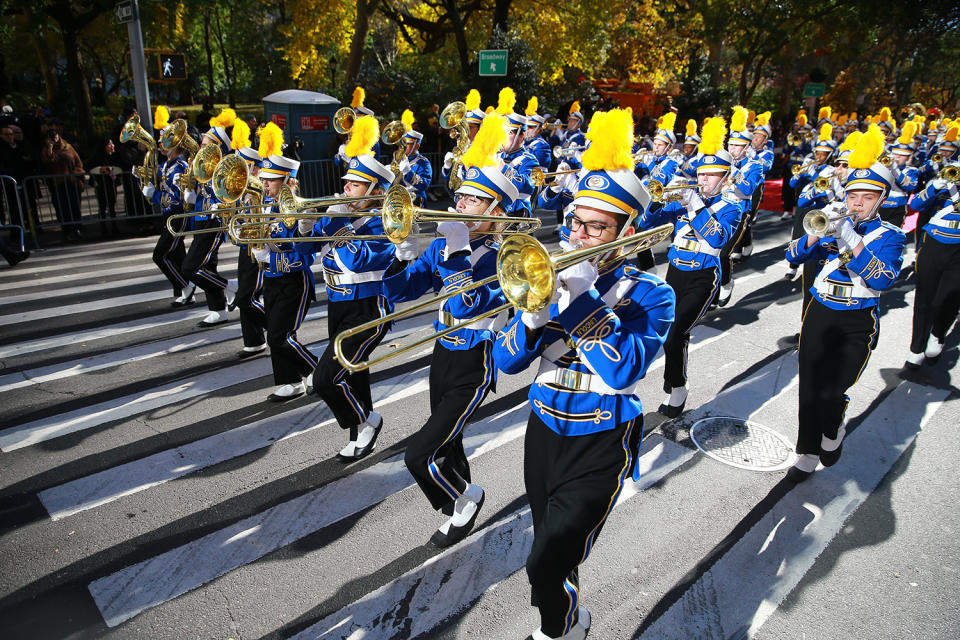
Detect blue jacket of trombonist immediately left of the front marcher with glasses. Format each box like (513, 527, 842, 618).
(383, 238, 506, 351)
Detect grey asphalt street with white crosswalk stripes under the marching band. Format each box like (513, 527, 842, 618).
(0, 211, 960, 640)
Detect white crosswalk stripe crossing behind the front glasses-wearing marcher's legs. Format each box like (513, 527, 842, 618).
(290, 436, 694, 640)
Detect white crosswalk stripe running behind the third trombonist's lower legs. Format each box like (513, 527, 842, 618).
(38, 367, 427, 520)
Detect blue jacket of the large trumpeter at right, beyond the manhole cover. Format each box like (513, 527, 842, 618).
(786, 203, 906, 311)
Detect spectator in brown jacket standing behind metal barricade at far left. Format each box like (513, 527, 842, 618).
(40, 127, 83, 241)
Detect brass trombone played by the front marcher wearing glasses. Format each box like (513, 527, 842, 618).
(333, 224, 673, 373)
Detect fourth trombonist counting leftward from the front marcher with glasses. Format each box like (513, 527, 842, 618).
(253, 152, 317, 402)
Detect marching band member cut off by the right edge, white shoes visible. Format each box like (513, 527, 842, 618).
(906, 164, 960, 369)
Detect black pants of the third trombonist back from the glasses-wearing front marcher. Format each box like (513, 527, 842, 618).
(313, 297, 389, 440)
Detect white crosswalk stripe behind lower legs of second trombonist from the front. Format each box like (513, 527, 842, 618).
(89, 402, 529, 627)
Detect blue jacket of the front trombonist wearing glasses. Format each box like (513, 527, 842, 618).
(493, 260, 676, 436)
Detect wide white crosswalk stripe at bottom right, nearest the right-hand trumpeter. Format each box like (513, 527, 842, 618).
(640, 382, 950, 640)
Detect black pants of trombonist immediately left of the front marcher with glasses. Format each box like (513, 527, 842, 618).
(403, 341, 495, 513)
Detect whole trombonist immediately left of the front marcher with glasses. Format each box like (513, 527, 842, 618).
(383, 114, 519, 547)
